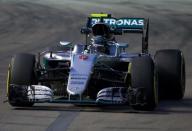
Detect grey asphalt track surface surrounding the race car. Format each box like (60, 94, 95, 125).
(0, 0, 192, 131)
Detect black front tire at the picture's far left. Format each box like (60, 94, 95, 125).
(7, 54, 35, 107)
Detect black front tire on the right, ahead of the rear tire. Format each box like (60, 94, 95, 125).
(131, 56, 158, 110)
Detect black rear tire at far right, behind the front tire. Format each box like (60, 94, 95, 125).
(155, 49, 185, 99)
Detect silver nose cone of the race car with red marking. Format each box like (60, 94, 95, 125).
(67, 54, 96, 95)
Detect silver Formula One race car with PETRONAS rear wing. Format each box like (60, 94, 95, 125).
(7, 14, 185, 110)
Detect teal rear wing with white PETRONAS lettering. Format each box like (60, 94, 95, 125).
(82, 13, 149, 53)
